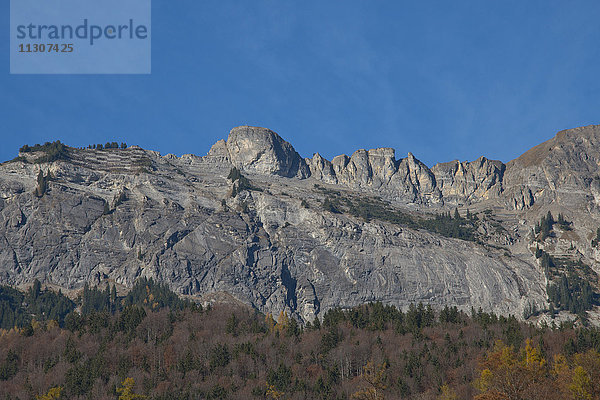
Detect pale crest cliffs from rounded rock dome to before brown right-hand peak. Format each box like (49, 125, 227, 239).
(208, 126, 505, 205)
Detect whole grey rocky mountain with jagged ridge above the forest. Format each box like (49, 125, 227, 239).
(0, 126, 600, 321)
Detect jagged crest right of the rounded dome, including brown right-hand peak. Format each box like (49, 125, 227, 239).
(307, 126, 600, 210)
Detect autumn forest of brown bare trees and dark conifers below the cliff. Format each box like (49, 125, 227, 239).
(0, 280, 600, 400)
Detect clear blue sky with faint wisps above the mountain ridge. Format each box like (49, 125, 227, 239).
(0, 0, 600, 166)
